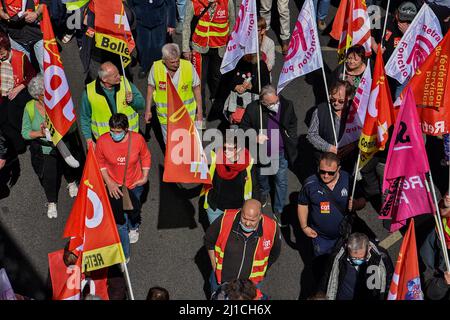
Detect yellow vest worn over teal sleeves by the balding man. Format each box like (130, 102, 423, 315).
(86, 77, 139, 139)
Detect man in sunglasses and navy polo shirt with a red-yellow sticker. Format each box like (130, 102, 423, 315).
(297, 152, 365, 281)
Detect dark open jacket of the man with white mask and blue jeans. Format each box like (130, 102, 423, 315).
(239, 95, 298, 166)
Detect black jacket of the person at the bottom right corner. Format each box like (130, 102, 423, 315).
(420, 229, 450, 300)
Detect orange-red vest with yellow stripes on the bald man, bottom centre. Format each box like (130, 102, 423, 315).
(214, 209, 277, 285)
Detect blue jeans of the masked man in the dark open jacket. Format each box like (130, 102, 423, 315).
(258, 153, 288, 213)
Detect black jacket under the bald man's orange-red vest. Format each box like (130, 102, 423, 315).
(204, 213, 281, 283)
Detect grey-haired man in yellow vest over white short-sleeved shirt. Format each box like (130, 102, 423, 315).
(145, 43, 203, 143)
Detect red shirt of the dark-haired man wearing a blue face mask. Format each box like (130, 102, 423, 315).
(95, 131, 151, 188)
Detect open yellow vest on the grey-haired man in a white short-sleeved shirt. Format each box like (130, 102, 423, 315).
(153, 59, 197, 125)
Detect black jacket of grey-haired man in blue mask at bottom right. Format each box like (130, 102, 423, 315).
(319, 243, 394, 300)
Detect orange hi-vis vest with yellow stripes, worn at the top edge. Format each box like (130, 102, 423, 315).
(192, 0, 230, 48)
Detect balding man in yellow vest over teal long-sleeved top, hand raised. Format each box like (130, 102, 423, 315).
(80, 62, 145, 143)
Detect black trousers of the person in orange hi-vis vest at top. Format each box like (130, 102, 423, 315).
(201, 49, 222, 117)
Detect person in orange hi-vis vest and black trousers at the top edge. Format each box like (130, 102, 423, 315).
(182, 0, 235, 123)
